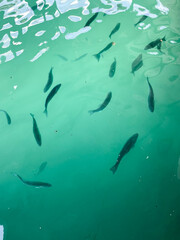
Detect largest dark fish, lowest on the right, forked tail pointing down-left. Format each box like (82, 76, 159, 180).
(110, 133, 139, 174)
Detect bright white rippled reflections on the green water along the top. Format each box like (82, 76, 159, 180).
(0, 0, 174, 63)
